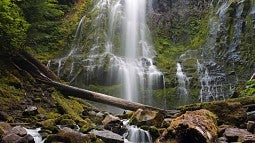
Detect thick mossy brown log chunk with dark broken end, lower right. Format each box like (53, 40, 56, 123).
(168, 109, 217, 143)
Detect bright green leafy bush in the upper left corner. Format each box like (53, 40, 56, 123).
(0, 0, 29, 51)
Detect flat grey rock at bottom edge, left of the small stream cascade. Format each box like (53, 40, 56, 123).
(90, 130, 124, 143)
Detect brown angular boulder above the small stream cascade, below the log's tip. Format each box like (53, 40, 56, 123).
(130, 109, 164, 127)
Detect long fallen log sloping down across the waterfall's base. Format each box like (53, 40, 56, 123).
(13, 52, 175, 115)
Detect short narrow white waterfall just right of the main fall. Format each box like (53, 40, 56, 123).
(176, 63, 188, 100)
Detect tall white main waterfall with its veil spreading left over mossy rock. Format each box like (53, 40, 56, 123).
(48, 0, 164, 105)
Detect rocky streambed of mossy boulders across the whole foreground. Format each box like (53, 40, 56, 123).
(0, 97, 255, 143)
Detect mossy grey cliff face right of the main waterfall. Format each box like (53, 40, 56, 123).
(149, 0, 255, 104)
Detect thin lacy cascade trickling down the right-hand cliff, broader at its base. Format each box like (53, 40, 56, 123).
(197, 0, 231, 102)
